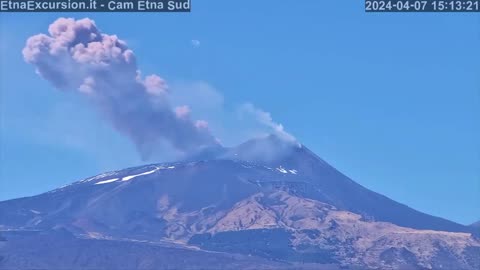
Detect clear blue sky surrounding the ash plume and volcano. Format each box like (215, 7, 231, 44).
(0, 1, 480, 224)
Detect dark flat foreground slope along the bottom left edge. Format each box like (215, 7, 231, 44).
(0, 231, 339, 270)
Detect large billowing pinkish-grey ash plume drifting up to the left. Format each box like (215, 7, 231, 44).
(23, 18, 218, 158)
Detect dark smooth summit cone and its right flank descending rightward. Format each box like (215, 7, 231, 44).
(218, 135, 471, 232)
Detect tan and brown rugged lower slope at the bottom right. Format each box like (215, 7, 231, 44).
(189, 191, 480, 269)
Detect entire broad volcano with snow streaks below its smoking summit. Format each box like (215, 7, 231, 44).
(0, 135, 480, 269)
